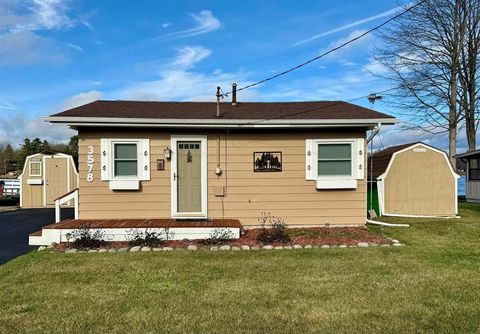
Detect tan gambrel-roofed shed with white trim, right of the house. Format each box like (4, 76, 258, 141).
(368, 142, 459, 217)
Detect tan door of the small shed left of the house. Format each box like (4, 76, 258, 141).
(45, 158, 68, 205)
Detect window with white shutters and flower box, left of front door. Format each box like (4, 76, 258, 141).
(101, 138, 150, 190)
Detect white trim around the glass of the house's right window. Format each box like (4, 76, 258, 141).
(310, 139, 357, 180)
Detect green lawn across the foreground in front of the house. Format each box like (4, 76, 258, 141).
(0, 204, 480, 333)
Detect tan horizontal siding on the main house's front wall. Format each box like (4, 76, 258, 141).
(79, 129, 366, 226)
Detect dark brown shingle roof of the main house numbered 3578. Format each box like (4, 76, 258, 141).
(52, 100, 394, 120)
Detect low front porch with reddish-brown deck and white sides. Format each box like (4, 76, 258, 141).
(28, 218, 242, 246)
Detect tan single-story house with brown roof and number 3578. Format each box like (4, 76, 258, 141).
(31, 96, 397, 244)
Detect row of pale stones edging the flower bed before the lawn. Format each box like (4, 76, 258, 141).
(38, 238, 405, 254)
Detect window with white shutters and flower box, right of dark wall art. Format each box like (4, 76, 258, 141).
(306, 139, 365, 189)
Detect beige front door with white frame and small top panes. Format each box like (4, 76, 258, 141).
(171, 136, 207, 219)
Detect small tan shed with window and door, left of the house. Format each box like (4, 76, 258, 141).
(18, 151, 78, 208)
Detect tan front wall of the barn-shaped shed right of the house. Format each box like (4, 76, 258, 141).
(384, 147, 457, 216)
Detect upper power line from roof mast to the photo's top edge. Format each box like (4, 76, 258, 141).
(225, 0, 427, 95)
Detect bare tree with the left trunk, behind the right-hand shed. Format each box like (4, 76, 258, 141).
(375, 0, 470, 166)
